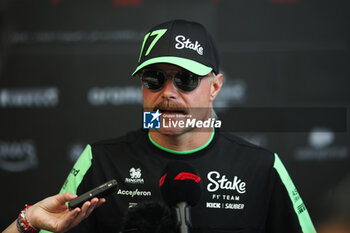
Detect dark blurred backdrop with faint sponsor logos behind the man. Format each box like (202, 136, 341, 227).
(0, 0, 350, 232)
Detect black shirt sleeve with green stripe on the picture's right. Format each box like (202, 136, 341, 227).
(266, 154, 316, 233)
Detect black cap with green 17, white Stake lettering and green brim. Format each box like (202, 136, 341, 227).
(132, 19, 219, 76)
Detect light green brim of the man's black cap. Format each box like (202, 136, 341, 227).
(132, 57, 213, 76)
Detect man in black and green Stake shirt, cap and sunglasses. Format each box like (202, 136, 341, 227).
(45, 20, 315, 233)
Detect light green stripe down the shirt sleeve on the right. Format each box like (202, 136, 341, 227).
(273, 153, 316, 233)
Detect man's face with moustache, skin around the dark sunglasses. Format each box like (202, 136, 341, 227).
(142, 63, 222, 135)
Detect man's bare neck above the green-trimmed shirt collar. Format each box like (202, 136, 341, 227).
(150, 130, 213, 151)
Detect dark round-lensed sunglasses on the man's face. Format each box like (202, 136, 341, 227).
(140, 69, 210, 92)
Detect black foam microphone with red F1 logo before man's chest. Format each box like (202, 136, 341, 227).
(159, 161, 202, 233)
